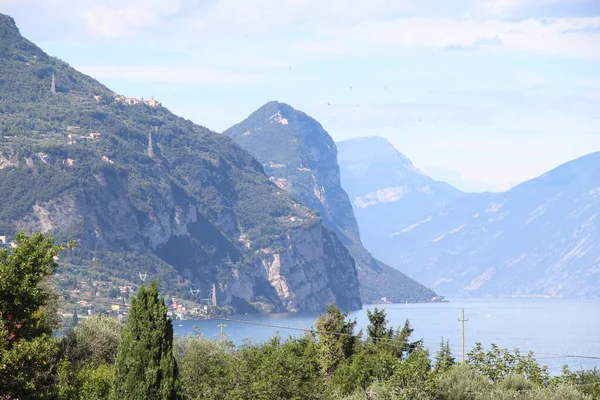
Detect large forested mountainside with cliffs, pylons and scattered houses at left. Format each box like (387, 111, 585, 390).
(0, 15, 362, 312)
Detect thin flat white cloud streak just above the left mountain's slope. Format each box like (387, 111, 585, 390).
(75, 65, 259, 84)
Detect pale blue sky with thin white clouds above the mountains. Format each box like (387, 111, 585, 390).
(0, 0, 600, 191)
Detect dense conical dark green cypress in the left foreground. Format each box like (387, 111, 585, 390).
(113, 280, 178, 400)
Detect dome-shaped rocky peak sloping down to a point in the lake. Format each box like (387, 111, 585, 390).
(224, 101, 435, 302)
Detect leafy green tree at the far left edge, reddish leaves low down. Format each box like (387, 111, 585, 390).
(0, 233, 73, 399)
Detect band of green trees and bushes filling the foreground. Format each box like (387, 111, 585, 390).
(0, 234, 600, 400)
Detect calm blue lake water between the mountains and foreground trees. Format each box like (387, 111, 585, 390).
(174, 299, 600, 374)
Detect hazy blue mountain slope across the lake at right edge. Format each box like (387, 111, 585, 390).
(378, 152, 600, 297)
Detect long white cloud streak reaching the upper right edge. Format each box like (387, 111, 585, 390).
(313, 17, 600, 59)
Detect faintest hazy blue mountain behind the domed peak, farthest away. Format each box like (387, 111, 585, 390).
(337, 136, 464, 253)
